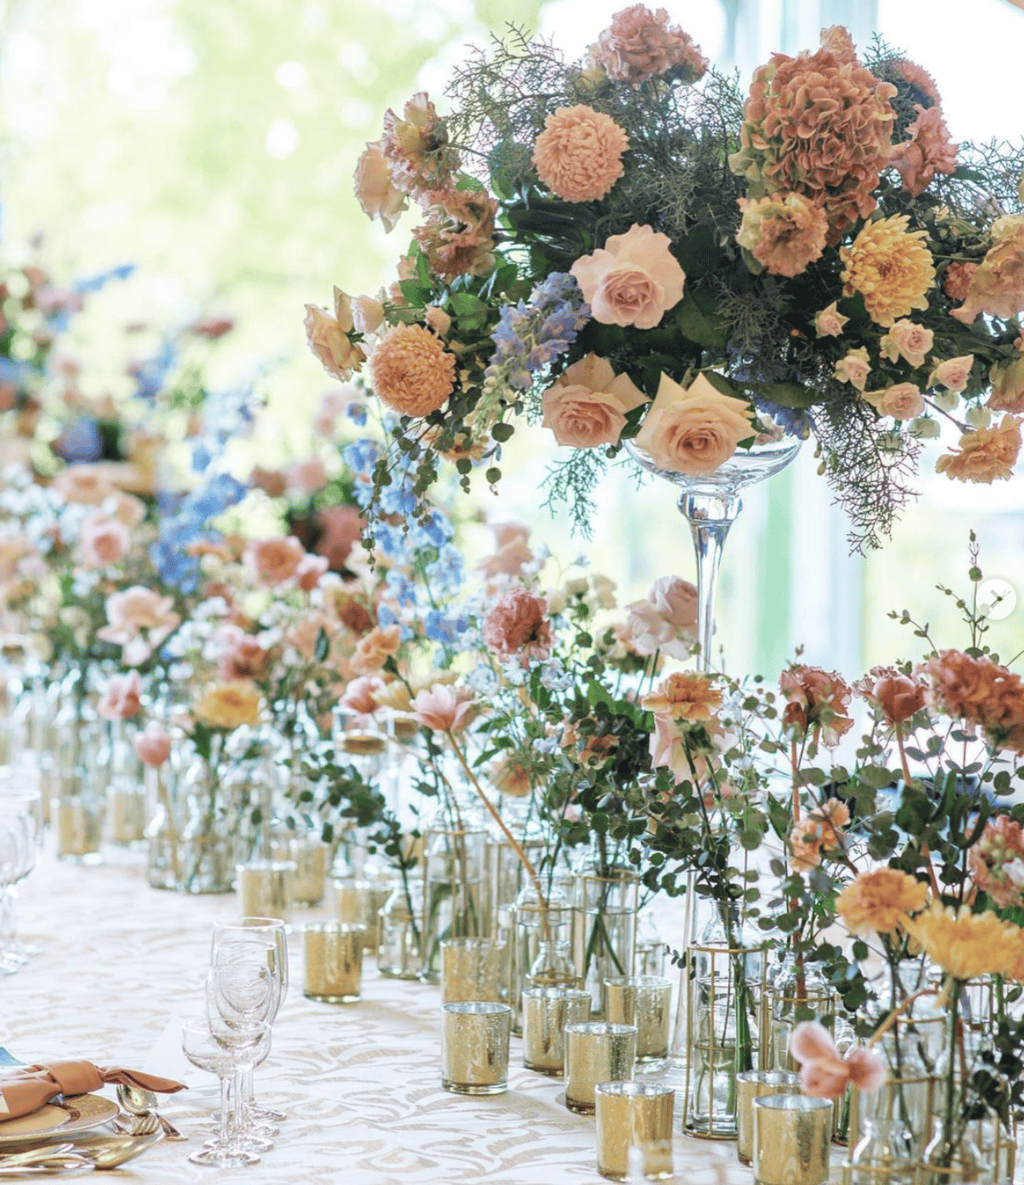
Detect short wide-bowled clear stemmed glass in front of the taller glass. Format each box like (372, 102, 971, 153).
(181, 1017, 270, 1168)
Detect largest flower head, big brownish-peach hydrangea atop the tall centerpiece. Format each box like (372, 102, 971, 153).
(729, 49, 896, 245)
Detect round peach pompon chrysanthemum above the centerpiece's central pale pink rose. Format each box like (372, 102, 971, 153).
(532, 103, 629, 201)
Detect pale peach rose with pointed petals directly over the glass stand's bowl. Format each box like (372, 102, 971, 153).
(636, 374, 754, 476)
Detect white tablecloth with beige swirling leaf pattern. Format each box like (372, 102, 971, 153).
(0, 852, 791, 1185)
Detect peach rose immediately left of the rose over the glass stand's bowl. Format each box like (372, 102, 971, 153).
(543, 352, 644, 448)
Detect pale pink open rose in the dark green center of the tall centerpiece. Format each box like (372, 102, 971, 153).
(569, 223, 686, 329)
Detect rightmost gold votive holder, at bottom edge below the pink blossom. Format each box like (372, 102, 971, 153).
(751, 1095, 832, 1185)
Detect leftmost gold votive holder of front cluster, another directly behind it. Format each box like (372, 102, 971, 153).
(441, 1000, 512, 1095)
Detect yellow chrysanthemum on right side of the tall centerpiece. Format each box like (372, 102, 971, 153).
(839, 214, 935, 328)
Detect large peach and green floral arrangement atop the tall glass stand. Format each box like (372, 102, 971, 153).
(306, 5, 1024, 546)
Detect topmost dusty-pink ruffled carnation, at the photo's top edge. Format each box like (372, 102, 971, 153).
(591, 4, 708, 87)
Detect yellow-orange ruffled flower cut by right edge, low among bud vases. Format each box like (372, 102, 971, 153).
(904, 901, 1024, 980)
